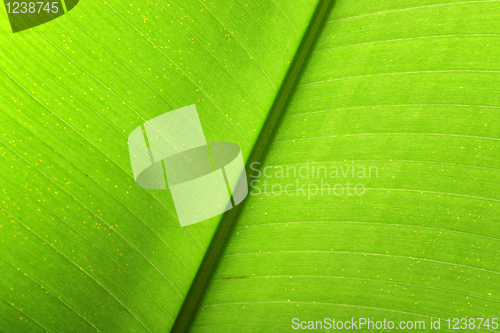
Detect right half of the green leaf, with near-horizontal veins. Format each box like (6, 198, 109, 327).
(188, 1, 500, 332)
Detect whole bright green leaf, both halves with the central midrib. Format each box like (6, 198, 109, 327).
(0, 0, 500, 332)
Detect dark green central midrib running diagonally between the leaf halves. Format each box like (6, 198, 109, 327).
(170, 0, 334, 333)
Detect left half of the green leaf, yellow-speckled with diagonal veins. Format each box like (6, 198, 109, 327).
(0, 1, 315, 332)
